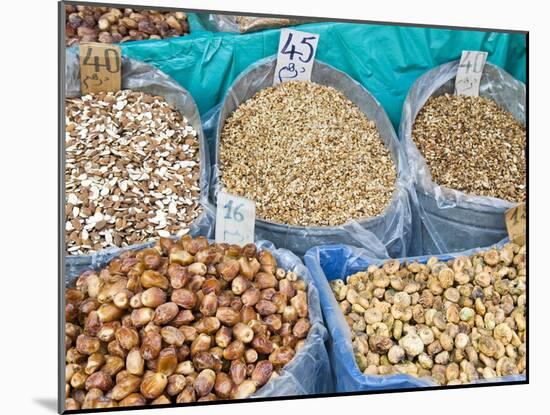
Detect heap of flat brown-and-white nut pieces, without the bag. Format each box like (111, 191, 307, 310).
(65, 90, 200, 255)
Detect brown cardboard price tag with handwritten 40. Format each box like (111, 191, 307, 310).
(80, 43, 122, 95)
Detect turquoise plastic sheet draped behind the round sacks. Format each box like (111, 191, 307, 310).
(120, 21, 526, 130)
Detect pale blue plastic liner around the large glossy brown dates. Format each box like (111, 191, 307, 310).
(65, 241, 334, 398)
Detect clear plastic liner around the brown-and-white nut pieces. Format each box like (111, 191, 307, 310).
(63, 48, 212, 276)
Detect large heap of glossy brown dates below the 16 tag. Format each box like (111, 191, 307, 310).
(65, 236, 310, 409)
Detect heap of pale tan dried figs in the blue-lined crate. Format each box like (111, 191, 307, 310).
(331, 243, 527, 385)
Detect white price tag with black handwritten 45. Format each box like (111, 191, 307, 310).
(273, 29, 319, 85)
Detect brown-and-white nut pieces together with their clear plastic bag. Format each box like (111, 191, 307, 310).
(64, 50, 211, 282)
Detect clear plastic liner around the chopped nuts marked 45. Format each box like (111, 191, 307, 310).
(204, 56, 412, 257)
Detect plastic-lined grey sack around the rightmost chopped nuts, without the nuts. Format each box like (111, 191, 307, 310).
(399, 61, 526, 254)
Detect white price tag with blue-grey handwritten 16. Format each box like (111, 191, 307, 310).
(216, 192, 256, 246)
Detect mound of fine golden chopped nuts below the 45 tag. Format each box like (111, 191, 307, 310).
(220, 82, 396, 226)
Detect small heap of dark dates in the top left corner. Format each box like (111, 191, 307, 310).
(65, 5, 189, 46)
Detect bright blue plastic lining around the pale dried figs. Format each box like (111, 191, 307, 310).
(304, 240, 525, 392)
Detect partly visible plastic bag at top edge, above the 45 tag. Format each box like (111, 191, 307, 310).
(200, 14, 307, 33)
